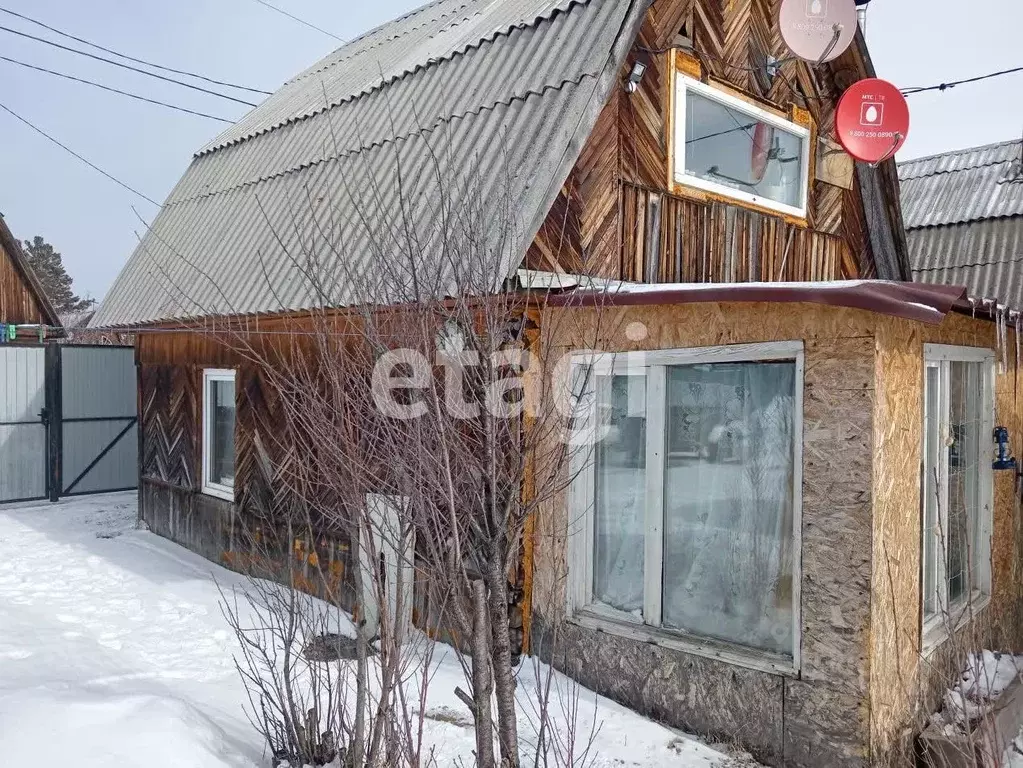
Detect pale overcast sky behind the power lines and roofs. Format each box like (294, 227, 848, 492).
(0, 0, 1023, 298)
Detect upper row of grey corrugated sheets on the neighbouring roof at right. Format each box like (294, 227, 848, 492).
(898, 141, 1023, 229)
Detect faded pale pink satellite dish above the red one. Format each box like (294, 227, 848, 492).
(777, 0, 857, 63)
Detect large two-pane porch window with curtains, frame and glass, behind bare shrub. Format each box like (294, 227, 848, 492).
(570, 343, 802, 669)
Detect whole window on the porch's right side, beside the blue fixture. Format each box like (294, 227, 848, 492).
(921, 345, 994, 646)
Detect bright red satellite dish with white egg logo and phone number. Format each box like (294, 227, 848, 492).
(835, 79, 909, 163)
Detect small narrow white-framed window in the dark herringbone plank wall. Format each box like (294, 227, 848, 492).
(203, 370, 234, 501)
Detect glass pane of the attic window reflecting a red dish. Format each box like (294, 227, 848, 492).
(679, 90, 806, 210)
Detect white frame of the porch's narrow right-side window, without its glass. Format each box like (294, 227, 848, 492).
(920, 344, 995, 653)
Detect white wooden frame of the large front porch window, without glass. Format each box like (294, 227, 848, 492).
(566, 342, 804, 676)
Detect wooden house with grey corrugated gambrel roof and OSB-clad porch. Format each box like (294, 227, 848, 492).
(91, 0, 1023, 766)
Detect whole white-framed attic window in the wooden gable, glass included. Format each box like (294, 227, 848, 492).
(673, 75, 810, 218)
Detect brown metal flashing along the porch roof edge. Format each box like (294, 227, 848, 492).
(547, 280, 966, 325)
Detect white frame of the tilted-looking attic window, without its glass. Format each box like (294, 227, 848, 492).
(671, 73, 811, 219)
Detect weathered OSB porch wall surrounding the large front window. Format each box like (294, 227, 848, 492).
(533, 304, 876, 766)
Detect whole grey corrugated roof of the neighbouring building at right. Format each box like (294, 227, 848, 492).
(899, 140, 1023, 309)
